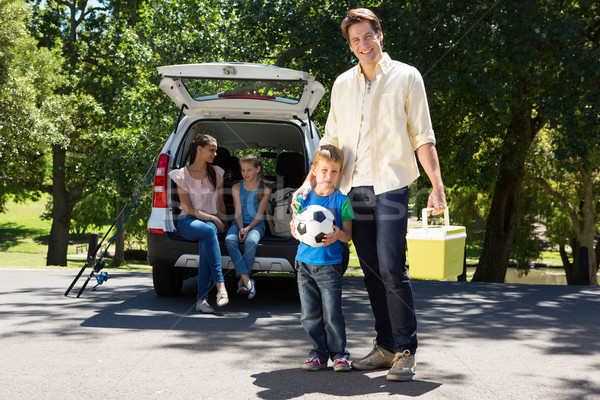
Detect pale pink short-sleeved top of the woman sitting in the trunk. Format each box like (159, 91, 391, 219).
(169, 165, 225, 215)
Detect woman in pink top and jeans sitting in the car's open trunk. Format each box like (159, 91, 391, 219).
(169, 135, 229, 314)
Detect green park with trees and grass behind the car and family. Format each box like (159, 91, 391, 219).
(0, 0, 600, 285)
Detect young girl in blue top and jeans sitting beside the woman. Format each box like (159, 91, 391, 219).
(225, 154, 271, 299)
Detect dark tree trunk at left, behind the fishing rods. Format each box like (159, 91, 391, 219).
(46, 145, 72, 266)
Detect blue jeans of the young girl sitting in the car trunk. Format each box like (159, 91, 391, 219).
(225, 222, 265, 276)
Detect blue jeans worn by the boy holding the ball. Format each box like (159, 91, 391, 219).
(296, 261, 350, 361)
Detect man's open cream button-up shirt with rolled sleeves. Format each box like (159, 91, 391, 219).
(320, 53, 435, 194)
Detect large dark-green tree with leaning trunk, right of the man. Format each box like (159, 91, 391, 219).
(382, 0, 597, 282)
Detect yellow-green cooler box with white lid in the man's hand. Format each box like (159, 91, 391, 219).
(406, 208, 467, 279)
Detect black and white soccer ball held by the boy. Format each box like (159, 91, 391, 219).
(294, 204, 335, 247)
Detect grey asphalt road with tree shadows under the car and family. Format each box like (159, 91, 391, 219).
(0, 269, 600, 400)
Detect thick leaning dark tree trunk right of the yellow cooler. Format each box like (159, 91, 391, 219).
(472, 102, 542, 283)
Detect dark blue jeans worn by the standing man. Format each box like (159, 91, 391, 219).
(348, 186, 417, 354)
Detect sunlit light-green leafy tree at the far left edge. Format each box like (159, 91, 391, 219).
(0, 0, 63, 212)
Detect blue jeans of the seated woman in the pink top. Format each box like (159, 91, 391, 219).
(177, 215, 225, 300)
